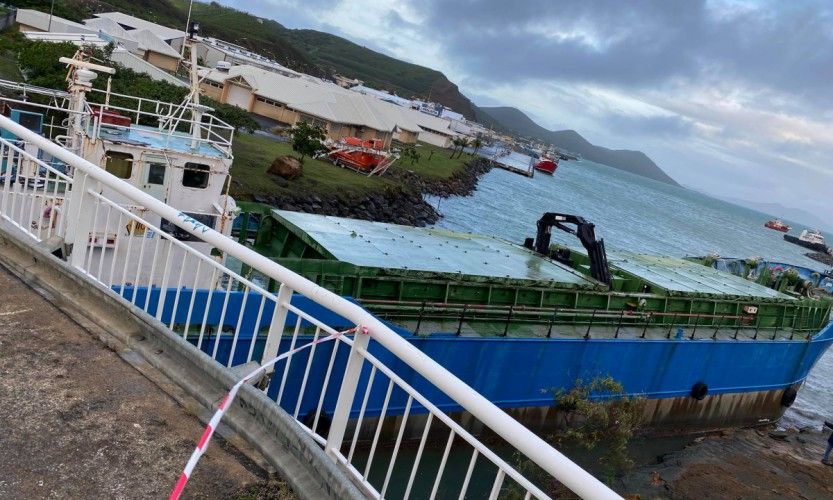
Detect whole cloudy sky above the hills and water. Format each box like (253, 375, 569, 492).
(223, 0, 833, 219)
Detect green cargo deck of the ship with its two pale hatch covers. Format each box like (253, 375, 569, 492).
(231, 204, 830, 339)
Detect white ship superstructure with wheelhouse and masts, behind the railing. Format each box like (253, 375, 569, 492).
(0, 30, 236, 285)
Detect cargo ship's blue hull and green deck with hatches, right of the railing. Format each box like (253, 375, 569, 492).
(231, 206, 833, 429)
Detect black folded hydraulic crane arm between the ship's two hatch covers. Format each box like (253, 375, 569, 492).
(533, 212, 611, 286)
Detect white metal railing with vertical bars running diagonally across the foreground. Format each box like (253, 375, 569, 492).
(0, 117, 618, 498)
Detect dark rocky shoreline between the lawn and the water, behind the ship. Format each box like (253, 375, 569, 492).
(252, 158, 492, 227)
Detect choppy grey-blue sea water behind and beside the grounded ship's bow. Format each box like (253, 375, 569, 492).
(427, 157, 833, 427)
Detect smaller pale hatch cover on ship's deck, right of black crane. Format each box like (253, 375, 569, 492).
(608, 251, 793, 300)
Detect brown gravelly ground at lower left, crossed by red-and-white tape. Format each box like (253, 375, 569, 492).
(0, 267, 266, 498)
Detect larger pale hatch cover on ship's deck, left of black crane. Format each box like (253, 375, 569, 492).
(273, 210, 598, 289)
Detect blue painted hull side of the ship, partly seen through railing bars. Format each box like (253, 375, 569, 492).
(118, 289, 833, 430)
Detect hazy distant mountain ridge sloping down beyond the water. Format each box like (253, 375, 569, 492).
(475, 106, 679, 186)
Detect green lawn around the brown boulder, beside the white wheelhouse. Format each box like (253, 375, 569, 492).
(231, 133, 394, 199)
